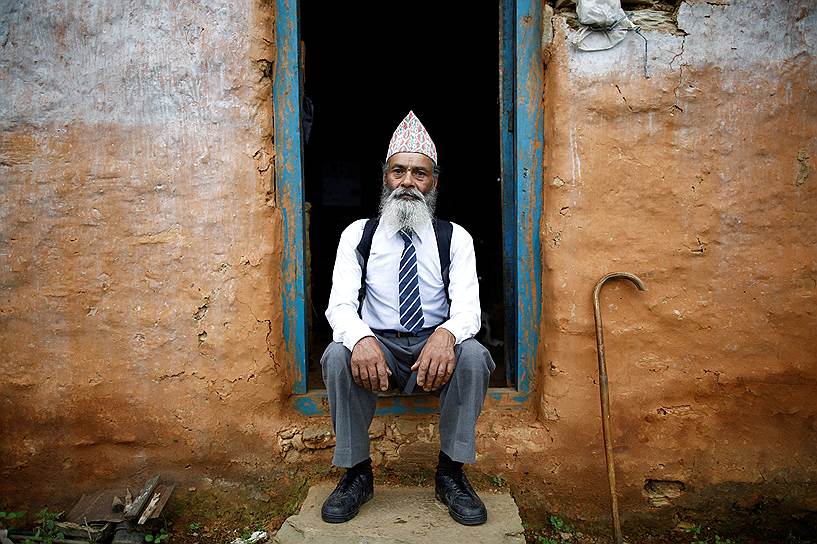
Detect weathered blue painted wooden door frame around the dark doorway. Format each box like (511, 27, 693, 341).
(273, 0, 544, 415)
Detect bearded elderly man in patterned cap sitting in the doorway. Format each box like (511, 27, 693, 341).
(321, 112, 495, 525)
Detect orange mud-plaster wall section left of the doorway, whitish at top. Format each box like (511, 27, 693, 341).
(0, 0, 288, 506)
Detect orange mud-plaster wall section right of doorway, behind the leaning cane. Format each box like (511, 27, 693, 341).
(518, 0, 817, 528)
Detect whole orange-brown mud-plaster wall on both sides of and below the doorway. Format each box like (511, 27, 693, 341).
(0, 0, 817, 536)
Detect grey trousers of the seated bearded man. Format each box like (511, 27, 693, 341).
(321, 333, 496, 467)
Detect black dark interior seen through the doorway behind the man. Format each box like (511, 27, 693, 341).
(300, 0, 508, 389)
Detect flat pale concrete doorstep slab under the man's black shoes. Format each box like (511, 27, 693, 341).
(273, 482, 525, 544)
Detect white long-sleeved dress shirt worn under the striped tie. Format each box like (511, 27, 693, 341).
(326, 219, 481, 350)
